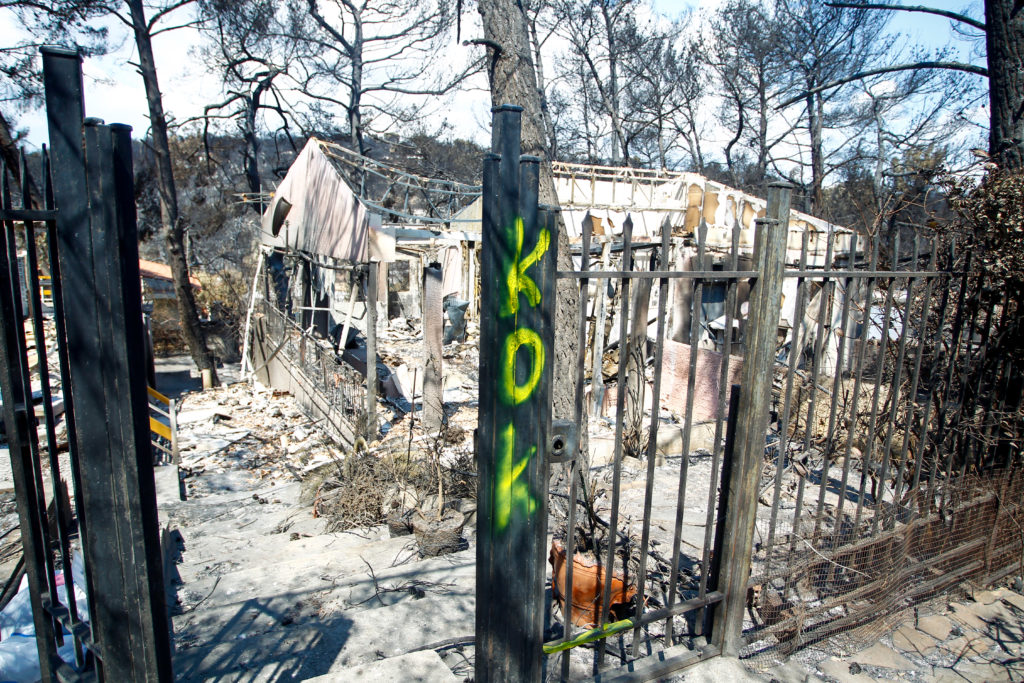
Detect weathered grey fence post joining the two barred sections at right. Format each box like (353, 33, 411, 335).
(712, 183, 793, 655)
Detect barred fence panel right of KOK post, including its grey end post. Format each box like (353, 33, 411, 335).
(545, 181, 788, 679)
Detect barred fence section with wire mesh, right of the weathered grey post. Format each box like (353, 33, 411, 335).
(742, 227, 1024, 668)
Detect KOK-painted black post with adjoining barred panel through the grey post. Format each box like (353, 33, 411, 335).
(476, 105, 790, 681)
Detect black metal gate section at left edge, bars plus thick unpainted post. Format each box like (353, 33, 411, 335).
(0, 48, 171, 681)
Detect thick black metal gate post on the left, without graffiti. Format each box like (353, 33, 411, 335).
(43, 49, 172, 681)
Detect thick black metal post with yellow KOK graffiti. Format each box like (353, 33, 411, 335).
(475, 104, 557, 681)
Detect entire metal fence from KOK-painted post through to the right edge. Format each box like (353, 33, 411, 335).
(468, 102, 1024, 681)
